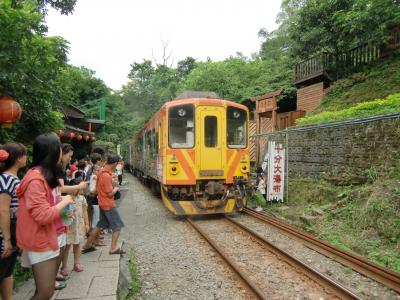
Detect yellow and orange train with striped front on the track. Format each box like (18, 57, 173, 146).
(129, 97, 250, 216)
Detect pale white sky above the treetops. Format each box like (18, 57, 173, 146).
(46, 0, 281, 90)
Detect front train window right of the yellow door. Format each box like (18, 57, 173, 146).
(226, 107, 247, 148)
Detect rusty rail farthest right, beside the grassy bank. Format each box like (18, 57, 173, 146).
(243, 208, 400, 293)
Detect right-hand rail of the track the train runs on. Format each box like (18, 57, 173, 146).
(226, 217, 362, 299)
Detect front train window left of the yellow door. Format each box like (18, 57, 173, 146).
(168, 105, 194, 148)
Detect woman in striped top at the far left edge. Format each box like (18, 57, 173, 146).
(0, 143, 27, 300)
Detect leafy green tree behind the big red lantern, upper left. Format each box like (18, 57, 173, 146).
(0, 1, 68, 143)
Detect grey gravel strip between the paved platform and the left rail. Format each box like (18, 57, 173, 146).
(119, 174, 254, 299)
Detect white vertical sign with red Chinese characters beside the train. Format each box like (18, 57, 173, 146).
(268, 142, 285, 202)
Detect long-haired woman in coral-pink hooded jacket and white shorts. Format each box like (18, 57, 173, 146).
(17, 134, 73, 300)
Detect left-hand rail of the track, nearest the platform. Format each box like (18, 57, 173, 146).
(186, 218, 268, 300)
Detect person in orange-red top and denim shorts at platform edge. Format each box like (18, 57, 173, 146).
(82, 153, 125, 254)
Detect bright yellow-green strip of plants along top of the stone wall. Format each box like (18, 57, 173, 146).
(297, 93, 400, 125)
